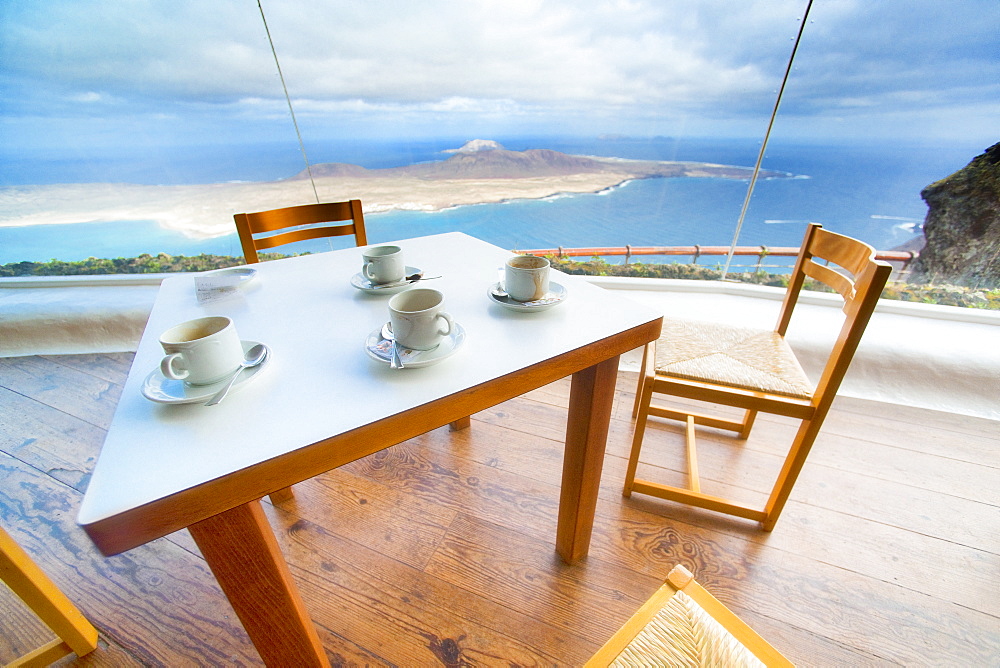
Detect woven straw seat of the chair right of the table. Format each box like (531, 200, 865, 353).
(656, 318, 813, 399)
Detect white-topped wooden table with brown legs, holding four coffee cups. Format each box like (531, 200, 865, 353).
(78, 233, 661, 666)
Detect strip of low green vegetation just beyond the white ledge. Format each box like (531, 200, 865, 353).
(0, 253, 1000, 310)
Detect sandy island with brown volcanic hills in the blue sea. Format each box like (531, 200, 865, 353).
(0, 140, 789, 238)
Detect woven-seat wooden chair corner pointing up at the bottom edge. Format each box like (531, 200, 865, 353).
(585, 566, 793, 668)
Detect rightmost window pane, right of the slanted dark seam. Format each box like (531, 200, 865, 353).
(740, 0, 1000, 270)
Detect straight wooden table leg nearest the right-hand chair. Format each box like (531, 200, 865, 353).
(556, 356, 618, 564)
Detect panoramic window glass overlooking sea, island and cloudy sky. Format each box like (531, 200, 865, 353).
(0, 0, 1000, 274)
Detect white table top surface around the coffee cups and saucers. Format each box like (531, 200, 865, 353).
(78, 233, 660, 526)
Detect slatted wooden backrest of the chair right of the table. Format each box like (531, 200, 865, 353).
(775, 223, 892, 411)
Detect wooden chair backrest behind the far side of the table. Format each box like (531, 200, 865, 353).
(233, 199, 368, 264)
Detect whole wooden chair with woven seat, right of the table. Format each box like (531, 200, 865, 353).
(624, 223, 892, 531)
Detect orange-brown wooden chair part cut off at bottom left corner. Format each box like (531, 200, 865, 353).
(0, 528, 97, 666)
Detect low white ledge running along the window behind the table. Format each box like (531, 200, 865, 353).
(0, 274, 1000, 420)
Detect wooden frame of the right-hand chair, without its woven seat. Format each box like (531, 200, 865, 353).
(623, 223, 892, 531)
